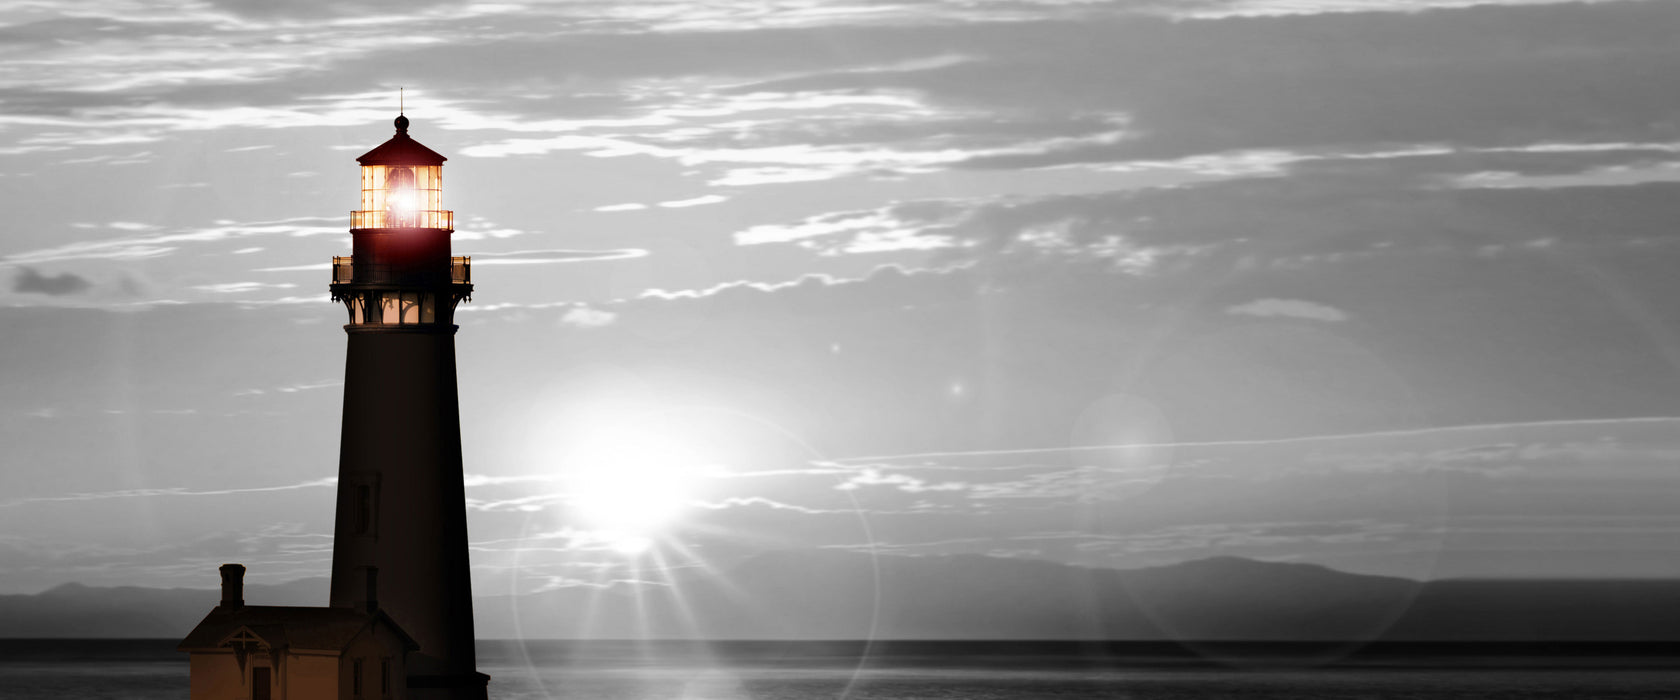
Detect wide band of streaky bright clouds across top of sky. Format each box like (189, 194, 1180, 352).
(16, 0, 1680, 192)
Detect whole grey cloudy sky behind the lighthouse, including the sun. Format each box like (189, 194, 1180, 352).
(0, 0, 1680, 593)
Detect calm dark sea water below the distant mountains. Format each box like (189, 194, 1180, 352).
(0, 640, 1680, 700)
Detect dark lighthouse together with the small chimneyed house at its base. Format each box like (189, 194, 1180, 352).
(181, 116, 489, 700)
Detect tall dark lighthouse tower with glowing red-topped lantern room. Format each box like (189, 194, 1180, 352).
(329, 116, 489, 700)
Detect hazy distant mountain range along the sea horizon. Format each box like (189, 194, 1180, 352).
(0, 551, 1680, 641)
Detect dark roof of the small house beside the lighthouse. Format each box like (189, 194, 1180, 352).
(175, 606, 420, 651)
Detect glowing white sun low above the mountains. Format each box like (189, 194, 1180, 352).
(559, 420, 704, 554)
